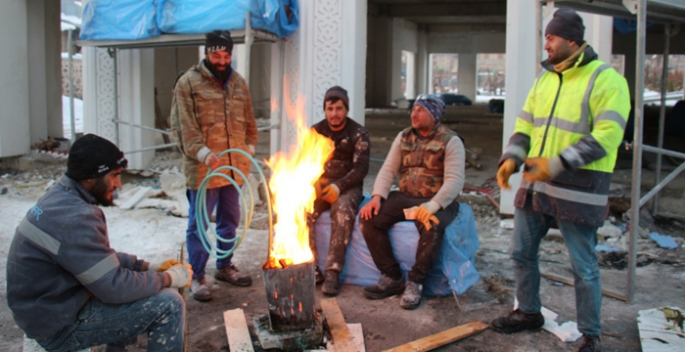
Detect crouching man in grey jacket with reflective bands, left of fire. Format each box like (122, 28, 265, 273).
(7, 134, 193, 351)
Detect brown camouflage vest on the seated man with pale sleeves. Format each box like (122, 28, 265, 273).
(399, 124, 457, 198)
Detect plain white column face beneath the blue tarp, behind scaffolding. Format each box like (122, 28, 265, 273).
(117, 49, 155, 169)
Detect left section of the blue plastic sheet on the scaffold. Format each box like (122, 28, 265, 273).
(79, 0, 162, 40)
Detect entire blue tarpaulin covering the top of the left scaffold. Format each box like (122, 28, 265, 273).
(80, 0, 300, 40)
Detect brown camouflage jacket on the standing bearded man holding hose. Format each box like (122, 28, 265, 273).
(171, 61, 257, 190)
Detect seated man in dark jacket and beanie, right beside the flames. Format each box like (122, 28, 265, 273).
(308, 86, 371, 296)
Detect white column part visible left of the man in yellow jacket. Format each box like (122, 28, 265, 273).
(500, 0, 537, 214)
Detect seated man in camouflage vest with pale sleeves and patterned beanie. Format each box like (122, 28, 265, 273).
(359, 94, 465, 309)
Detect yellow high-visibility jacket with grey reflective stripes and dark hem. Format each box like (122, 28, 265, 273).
(500, 46, 630, 226)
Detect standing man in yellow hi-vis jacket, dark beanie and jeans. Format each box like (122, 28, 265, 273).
(491, 9, 630, 351)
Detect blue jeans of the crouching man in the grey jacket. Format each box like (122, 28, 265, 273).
(37, 288, 186, 352)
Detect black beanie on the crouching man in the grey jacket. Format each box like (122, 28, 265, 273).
(67, 134, 128, 181)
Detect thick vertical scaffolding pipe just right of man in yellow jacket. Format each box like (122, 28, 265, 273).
(626, 0, 647, 303)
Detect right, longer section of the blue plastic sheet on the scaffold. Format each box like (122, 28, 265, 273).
(162, 0, 300, 37)
